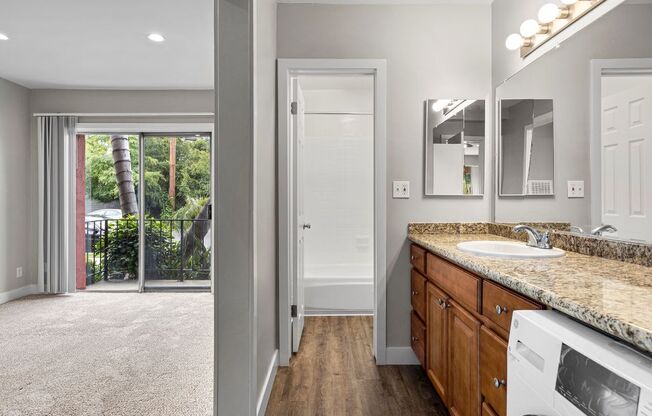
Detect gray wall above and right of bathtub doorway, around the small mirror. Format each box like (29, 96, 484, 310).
(277, 4, 492, 347)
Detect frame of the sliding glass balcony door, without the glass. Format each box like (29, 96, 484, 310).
(75, 122, 217, 293)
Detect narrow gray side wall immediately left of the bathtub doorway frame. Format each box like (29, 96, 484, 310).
(254, 0, 278, 406)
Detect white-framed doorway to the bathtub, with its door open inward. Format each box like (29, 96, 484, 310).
(278, 59, 386, 366)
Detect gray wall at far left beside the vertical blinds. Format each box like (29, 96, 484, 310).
(0, 78, 37, 293)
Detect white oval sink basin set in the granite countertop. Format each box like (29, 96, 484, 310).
(457, 241, 566, 259)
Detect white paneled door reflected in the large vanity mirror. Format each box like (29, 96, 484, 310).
(601, 77, 652, 240)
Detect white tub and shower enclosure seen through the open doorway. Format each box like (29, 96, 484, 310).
(303, 76, 374, 314)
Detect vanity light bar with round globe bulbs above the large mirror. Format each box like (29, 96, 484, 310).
(505, 0, 607, 58)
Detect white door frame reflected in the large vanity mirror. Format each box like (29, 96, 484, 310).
(589, 58, 652, 231)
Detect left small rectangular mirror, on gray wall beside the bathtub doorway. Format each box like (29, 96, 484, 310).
(424, 98, 485, 196)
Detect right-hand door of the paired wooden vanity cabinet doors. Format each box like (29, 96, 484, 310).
(448, 301, 480, 416)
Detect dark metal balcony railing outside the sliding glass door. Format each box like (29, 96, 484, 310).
(85, 218, 211, 285)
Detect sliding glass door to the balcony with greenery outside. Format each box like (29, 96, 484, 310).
(77, 126, 213, 292)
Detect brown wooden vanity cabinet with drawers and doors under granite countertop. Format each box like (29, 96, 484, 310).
(410, 245, 542, 416)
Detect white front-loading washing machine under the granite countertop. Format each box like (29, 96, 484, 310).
(507, 311, 652, 416)
